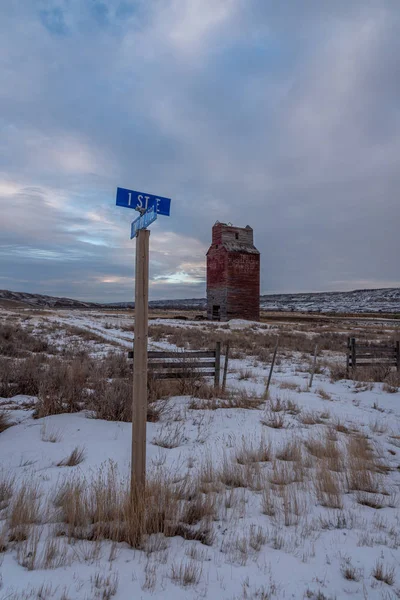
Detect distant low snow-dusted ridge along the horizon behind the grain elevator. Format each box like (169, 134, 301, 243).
(0, 288, 400, 314)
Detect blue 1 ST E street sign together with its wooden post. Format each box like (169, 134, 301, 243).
(116, 188, 171, 498)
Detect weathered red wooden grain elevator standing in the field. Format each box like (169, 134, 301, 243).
(207, 221, 260, 321)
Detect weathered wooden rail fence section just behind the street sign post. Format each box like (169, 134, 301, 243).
(128, 342, 221, 387)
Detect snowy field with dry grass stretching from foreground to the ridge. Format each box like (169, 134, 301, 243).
(0, 309, 400, 600)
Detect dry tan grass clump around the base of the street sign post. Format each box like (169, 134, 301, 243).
(54, 465, 217, 547)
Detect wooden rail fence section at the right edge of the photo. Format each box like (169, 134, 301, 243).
(346, 338, 400, 376)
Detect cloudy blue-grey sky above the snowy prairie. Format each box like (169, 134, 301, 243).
(0, 0, 400, 302)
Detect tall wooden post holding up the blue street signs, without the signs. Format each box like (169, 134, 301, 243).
(131, 229, 150, 499)
